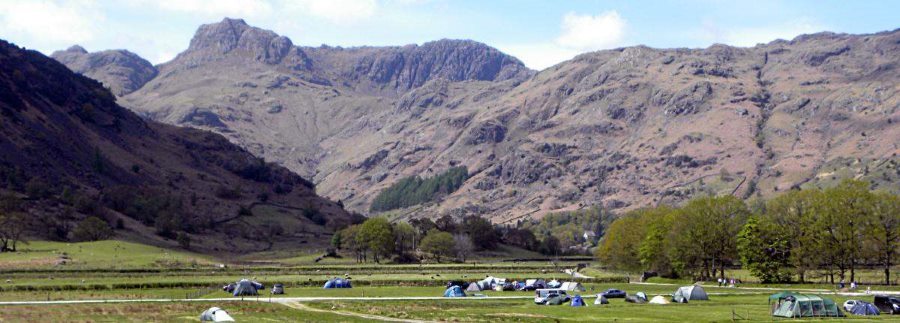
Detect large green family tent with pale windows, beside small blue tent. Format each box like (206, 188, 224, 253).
(769, 292, 844, 318)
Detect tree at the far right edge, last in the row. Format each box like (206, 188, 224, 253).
(863, 192, 900, 285)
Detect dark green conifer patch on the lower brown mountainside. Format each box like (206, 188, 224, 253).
(369, 166, 469, 212)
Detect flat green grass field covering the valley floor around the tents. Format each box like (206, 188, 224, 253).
(0, 241, 900, 322)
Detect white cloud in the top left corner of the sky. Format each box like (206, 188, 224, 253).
(0, 0, 104, 52)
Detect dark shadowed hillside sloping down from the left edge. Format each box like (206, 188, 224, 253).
(0, 41, 351, 252)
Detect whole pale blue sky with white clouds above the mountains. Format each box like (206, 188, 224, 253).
(0, 0, 900, 69)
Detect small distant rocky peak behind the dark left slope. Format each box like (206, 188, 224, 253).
(50, 45, 157, 95)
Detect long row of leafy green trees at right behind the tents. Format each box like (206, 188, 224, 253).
(595, 180, 900, 283)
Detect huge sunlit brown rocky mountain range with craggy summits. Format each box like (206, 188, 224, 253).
(58, 19, 900, 222)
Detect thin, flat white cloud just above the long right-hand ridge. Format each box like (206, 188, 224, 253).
(700, 18, 828, 47)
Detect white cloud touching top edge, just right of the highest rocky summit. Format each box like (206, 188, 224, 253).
(284, 0, 378, 24)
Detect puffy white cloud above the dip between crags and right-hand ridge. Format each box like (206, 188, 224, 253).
(556, 10, 625, 51)
